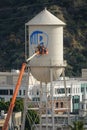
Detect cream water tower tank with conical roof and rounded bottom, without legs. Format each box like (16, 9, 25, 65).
(26, 9, 65, 82)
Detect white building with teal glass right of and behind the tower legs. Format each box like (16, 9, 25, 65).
(30, 78, 87, 115)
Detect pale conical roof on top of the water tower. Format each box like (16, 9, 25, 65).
(26, 9, 65, 26)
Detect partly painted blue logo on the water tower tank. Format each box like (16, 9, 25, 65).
(30, 30, 48, 53)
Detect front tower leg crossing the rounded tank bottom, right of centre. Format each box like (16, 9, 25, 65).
(50, 68, 54, 130)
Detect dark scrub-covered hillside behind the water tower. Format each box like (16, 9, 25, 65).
(0, 0, 87, 76)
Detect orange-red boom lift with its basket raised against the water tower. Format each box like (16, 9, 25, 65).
(2, 45, 48, 130)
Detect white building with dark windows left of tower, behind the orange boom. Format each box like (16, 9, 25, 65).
(0, 70, 35, 101)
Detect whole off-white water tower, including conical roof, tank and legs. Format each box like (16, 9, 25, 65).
(22, 9, 66, 130)
